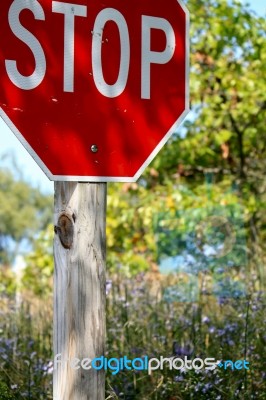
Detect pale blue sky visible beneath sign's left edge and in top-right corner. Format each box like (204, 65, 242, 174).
(0, 0, 266, 193)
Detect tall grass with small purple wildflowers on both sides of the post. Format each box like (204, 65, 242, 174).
(0, 273, 266, 400)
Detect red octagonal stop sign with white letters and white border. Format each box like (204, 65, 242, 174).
(0, 0, 189, 181)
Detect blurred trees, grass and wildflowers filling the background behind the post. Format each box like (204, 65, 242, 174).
(0, 0, 266, 400)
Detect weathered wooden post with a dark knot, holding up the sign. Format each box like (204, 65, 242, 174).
(53, 182, 106, 400)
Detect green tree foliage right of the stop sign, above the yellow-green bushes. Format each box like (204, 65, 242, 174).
(154, 0, 266, 178)
